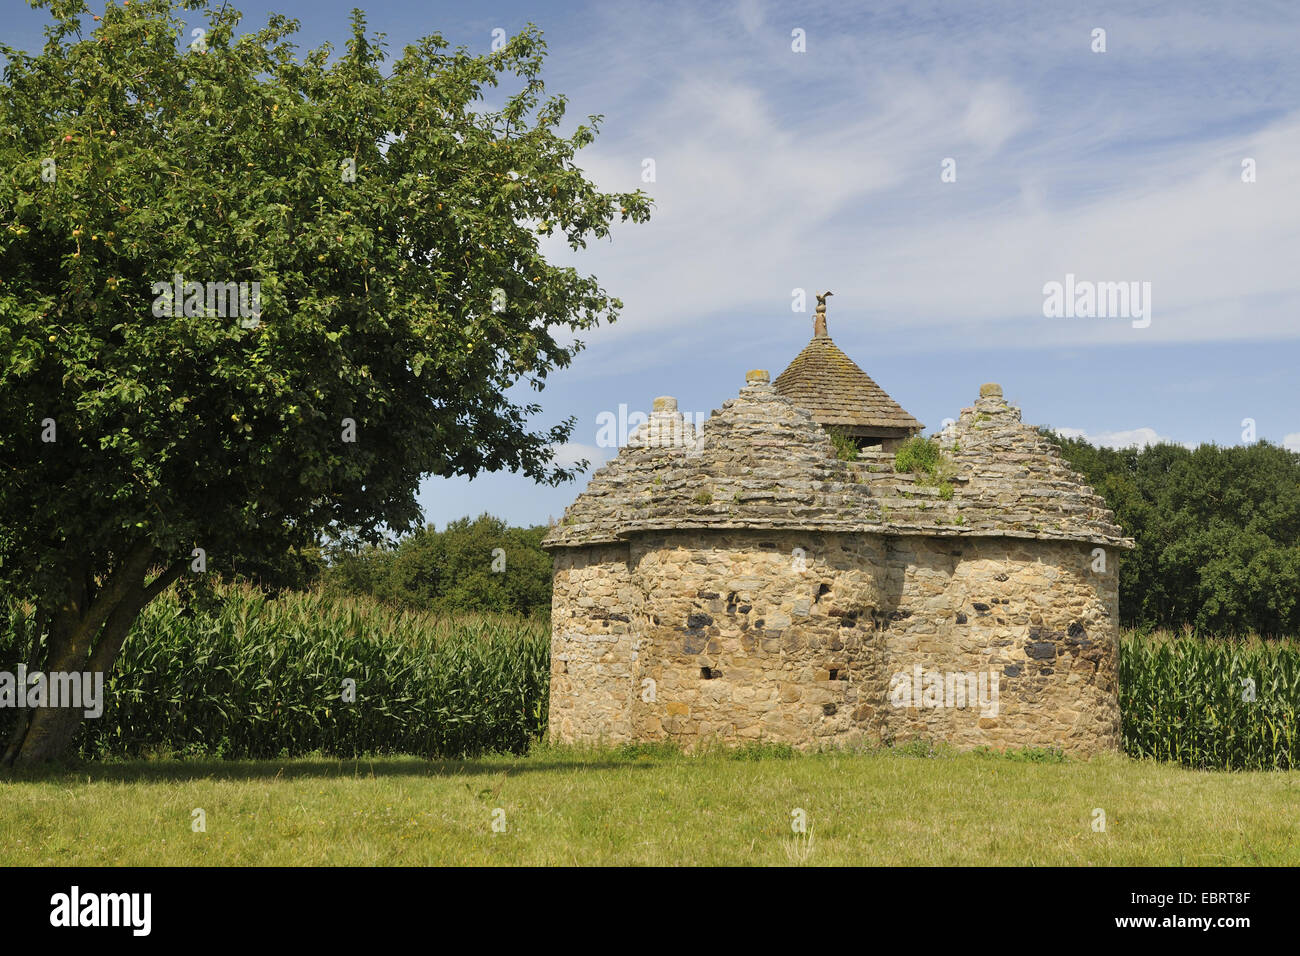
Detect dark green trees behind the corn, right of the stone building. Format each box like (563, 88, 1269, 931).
(1045, 432, 1300, 636)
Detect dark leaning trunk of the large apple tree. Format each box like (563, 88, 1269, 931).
(0, 545, 186, 766)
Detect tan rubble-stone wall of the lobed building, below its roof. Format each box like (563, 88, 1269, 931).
(550, 531, 1119, 754)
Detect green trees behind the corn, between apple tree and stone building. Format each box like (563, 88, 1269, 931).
(313, 514, 551, 615)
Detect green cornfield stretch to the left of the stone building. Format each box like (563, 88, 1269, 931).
(0, 588, 550, 757)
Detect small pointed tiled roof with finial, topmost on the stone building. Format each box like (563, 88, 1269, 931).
(774, 329, 924, 434)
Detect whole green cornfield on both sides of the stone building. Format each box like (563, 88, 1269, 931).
(0, 587, 1300, 770)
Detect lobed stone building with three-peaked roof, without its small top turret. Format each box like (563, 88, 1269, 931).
(545, 351, 1132, 754)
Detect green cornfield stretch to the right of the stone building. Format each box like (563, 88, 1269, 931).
(1119, 632, 1300, 770)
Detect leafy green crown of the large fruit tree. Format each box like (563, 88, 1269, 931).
(0, 0, 650, 760)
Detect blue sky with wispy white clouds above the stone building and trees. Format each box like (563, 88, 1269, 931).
(10, 0, 1300, 525)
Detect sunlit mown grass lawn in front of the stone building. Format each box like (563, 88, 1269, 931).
(0, 747, 1300, 866)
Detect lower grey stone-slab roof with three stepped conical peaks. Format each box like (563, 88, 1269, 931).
(542, 372, 1132, 549)
